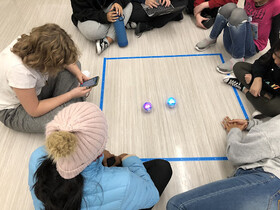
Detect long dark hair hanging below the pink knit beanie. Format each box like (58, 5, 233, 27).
(33, 156, 84, 210)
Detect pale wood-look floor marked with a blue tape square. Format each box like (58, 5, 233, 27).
(0, 0, 266, 210)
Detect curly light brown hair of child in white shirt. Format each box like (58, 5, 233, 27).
(11, 23, 79, 76)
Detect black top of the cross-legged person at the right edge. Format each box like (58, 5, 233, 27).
(252, 49, 280, 95)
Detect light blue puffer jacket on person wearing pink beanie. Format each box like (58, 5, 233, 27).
(28, 147, 159, 210)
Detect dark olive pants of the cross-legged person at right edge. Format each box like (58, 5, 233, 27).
(233, 62, 280, 117)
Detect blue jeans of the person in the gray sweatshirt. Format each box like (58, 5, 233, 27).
(167, 167, 280, 210)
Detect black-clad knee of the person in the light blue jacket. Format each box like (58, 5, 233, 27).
(143, 159, 172, 210)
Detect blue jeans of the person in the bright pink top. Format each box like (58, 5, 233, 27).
(210, 13, 257, 59)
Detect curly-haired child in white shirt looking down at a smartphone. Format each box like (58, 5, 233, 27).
(0, 24, 90, 133)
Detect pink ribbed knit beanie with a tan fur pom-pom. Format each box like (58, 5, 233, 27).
(46, 102, 107, 179)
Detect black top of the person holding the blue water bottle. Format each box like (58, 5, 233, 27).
(71, 0, 129, 26)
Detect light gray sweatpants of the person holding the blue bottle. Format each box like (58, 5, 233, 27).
(78, 3, 132, 41)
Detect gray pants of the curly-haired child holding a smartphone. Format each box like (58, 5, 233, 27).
(0, 63, 85, 133)
